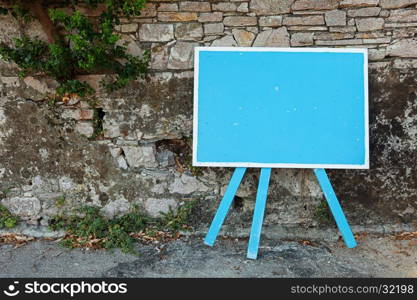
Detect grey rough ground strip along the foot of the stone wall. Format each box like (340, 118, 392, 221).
(0, 236, 417, 278)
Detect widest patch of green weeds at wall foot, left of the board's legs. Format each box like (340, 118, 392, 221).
(49, 201, 195, 253)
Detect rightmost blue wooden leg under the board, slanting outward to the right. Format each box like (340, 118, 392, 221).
(314, 169, 357, 248)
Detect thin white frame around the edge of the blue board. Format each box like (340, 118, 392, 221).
(192, 47, 369, 169)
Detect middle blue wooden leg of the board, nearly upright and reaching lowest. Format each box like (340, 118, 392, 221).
(247, 168, 271, 259)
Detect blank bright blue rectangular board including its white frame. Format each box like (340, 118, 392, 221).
(193, 47, 369, 169)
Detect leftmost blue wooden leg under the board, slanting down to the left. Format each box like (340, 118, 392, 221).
(204, 168, 246, 246)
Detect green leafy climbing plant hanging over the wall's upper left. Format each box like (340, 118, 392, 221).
(0, 0, 149, 96)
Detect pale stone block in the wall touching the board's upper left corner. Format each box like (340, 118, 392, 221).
(168, 42, 198, 69)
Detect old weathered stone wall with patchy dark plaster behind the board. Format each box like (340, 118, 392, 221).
(0, 0, 417, 234)
